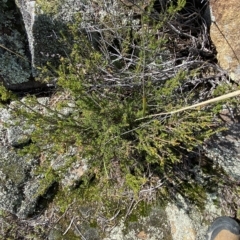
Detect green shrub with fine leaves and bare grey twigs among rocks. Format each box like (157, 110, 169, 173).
(6, 1, 227, 213)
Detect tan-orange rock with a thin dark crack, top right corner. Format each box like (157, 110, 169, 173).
(210, 0, 240, 81)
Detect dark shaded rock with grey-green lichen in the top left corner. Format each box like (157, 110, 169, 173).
(0, 0, 31, 87)
